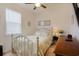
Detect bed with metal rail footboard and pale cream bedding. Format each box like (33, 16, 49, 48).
(12, 31, 52, 56)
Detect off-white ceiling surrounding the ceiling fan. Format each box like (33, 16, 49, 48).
(20, 3, 72, 14)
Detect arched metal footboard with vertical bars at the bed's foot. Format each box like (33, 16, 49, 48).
(11, 34, 37, 56)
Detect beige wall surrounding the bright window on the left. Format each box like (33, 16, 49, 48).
(0, 4, 36, 52)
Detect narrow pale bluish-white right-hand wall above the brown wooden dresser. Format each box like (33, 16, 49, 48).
(69, 3, 79, 42)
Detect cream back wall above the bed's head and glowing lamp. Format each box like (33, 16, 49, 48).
(37, 4, 71, 32)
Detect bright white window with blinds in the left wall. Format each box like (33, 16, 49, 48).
(6, 8, 21, 34)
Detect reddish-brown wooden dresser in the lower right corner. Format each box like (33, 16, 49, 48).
(54, 37, 79, 56)
